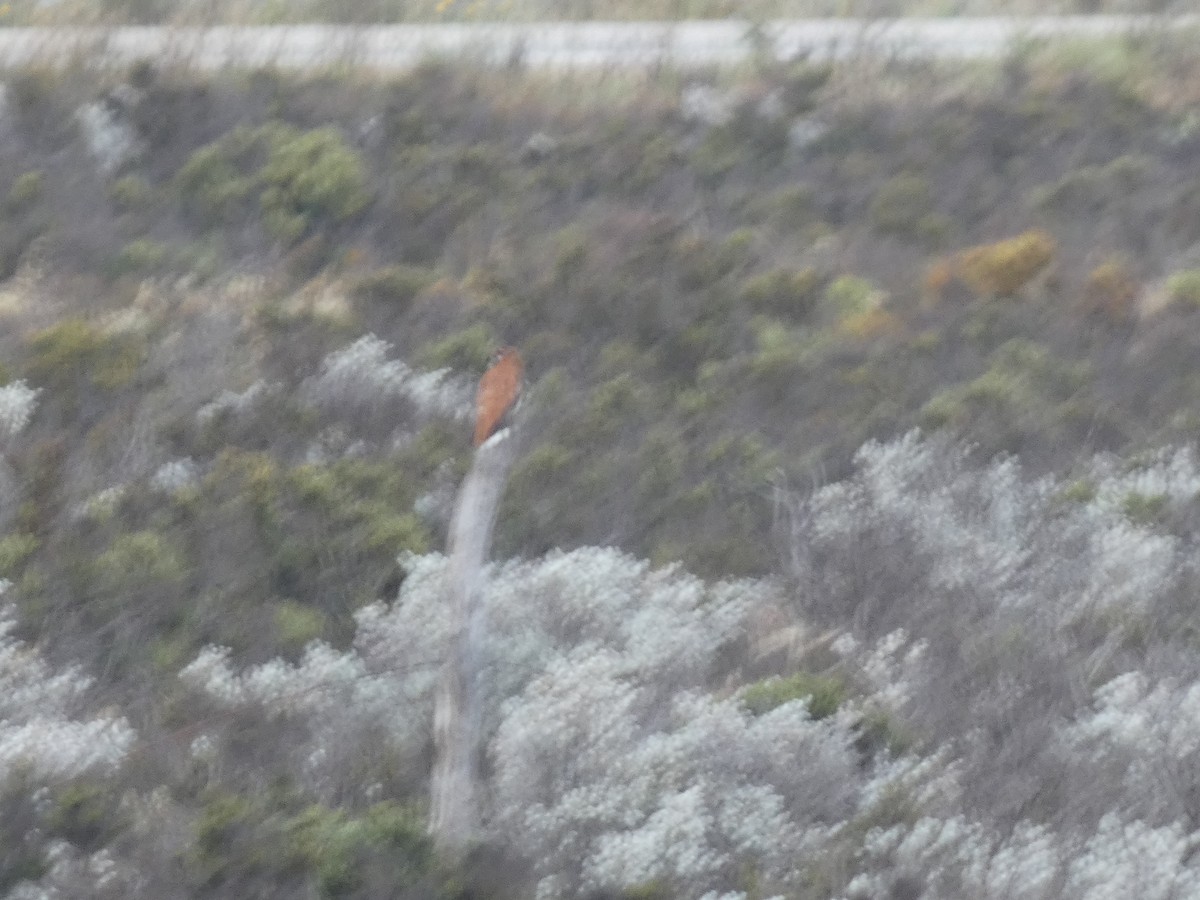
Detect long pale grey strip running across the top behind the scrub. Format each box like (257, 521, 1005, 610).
(0, 16, 1200, 70)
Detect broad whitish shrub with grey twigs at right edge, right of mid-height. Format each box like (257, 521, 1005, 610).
(787, 433, 1200, 792)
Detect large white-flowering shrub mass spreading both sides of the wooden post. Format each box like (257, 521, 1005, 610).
(182, 548, 858, 896)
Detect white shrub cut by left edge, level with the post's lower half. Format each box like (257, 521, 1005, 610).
(0, 611, 136, 781)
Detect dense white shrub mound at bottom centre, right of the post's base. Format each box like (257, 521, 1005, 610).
(493, 672, 856, 896)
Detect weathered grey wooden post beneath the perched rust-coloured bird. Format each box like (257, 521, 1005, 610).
(430, 428, 516, 857)
